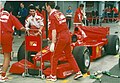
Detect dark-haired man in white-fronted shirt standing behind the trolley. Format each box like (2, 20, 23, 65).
(25, 5, 44, 36)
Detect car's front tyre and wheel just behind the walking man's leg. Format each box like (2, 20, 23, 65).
(72, 46, 90, 73)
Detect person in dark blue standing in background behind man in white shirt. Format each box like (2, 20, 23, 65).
(17, 3, 28, 38)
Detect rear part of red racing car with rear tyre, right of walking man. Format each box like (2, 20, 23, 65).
(72, 26, 119, 61)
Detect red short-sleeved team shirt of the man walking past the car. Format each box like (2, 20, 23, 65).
(48, 9, 68, 39)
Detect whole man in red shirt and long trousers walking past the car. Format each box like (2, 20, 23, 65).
(46, 1, 82, 81)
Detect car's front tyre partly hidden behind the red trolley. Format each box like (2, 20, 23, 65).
(17, 39, 48, 62)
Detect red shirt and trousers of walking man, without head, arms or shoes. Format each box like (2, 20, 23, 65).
(48, 9, 80, 76)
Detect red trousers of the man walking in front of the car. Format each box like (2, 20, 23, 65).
(51, 30, 80, 76)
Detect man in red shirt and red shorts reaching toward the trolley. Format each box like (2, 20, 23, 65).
(0, 2, 25, 82)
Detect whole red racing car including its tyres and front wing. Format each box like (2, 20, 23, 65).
(10, 26, 119, 78)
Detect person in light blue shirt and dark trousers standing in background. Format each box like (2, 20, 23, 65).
(66, 6, 73, 30)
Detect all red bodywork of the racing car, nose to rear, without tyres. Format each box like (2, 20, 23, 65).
(10, 26, 109, 78)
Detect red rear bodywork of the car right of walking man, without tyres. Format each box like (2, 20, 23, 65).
(72, 26, 109, 61)
